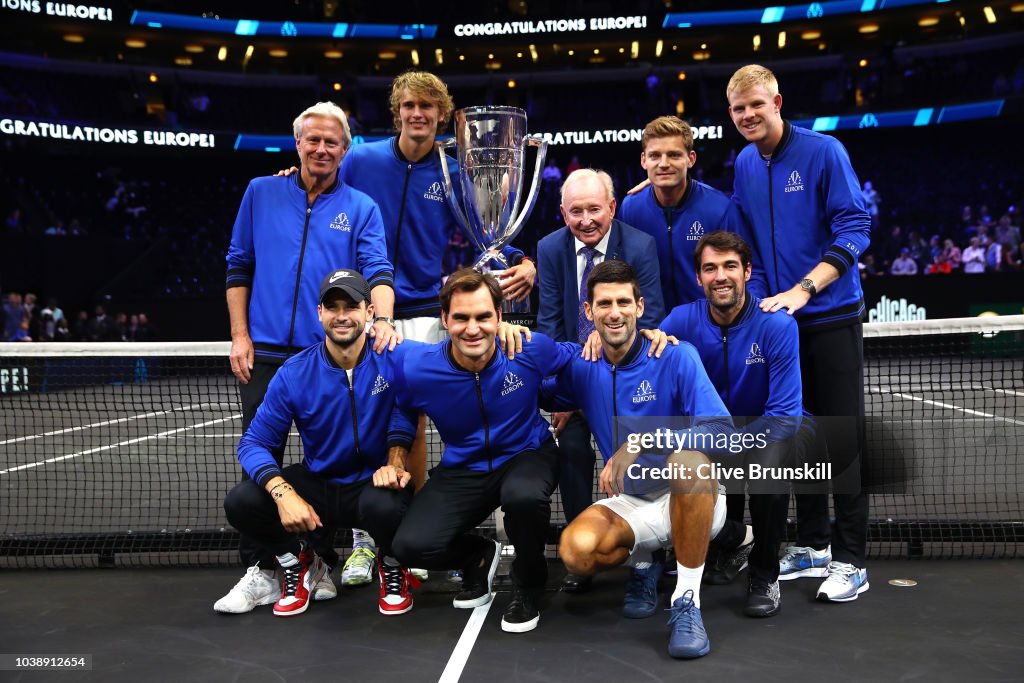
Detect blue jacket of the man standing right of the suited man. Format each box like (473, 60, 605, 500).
(618, 180, 760, 310)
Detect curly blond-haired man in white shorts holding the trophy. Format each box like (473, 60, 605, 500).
(341, 71, 537, 585)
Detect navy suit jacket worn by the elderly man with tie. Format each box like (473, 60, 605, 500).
(537, 219, 665, 342)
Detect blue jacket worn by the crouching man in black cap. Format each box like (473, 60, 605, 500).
(239, 337, 416, 486)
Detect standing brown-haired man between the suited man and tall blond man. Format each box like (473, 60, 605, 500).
(620, 116, 746, 310)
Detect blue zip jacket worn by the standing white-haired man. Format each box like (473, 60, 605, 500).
(227, 173, 393, 362)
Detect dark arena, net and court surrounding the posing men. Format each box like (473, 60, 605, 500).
(0, 0, 1024, 682)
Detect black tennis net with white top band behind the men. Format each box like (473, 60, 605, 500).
(0, 315, 1024, 567)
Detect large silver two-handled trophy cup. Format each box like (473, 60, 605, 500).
(439, 106, 548, 311)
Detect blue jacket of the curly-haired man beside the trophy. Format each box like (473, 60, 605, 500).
(340, 137, 522, 317)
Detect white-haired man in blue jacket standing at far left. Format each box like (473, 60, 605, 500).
(227, 102, 395, 593)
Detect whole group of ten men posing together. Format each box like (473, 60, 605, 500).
(215, 66, 870, 658)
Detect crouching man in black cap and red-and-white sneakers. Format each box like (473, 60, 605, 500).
(224, 269, 419, 616)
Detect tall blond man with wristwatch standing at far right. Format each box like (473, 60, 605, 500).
(726, 65, 871, 602)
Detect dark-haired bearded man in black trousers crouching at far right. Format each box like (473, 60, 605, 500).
(659, 231, 804, 616)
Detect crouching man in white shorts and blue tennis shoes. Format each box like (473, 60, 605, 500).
(545, 261, 753, 658)
